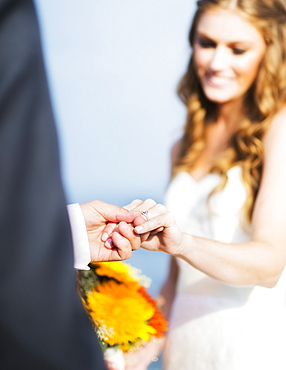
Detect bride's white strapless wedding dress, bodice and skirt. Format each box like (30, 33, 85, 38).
(163, 166, 286, 370)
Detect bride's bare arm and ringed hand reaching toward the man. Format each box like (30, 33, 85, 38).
(136, 109, 286, 287)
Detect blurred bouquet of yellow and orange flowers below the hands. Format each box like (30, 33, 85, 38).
(78, 262, 167, 368)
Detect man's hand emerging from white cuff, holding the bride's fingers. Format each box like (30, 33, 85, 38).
(80, 200, 141, 262)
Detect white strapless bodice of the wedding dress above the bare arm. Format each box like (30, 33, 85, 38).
(165, 166, 249, 243)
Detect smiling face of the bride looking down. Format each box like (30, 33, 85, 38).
(193, 9, 266, 104)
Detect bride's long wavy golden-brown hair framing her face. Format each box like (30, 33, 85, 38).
(173, 0, 286, 222)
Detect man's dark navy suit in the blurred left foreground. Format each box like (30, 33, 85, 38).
(0, 0, 104, 370)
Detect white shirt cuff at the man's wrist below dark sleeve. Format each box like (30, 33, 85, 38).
(67, 203, 91, 270)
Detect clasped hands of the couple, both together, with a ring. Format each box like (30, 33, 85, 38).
(80, 199, 182, 262)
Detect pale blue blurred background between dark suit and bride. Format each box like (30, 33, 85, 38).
(36, 0, 195, 369)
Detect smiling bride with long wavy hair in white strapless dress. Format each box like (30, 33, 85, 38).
(105, 0, 286, 370)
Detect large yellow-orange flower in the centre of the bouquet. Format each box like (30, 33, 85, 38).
(87, 280, 156, 350)
